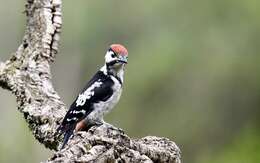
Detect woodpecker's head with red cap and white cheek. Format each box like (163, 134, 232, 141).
(105, 44, 128, 68)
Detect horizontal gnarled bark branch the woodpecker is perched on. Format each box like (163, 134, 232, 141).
(48, 125, 181, 163)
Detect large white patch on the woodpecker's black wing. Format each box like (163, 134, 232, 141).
(76, 81, 102, 106)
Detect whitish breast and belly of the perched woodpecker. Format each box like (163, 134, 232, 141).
(88, 76, 122, 120)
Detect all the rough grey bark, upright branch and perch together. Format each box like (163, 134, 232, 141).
(0, 0, 180, 163)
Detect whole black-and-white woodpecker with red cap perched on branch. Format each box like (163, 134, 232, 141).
(57, 44, 128, 148)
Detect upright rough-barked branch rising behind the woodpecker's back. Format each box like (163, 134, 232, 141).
(0, 0, 65, 149)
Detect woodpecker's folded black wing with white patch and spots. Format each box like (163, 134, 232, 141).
(59, 71, 114, 132)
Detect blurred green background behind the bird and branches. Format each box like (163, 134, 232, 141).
(0, 0, 260, 163)
